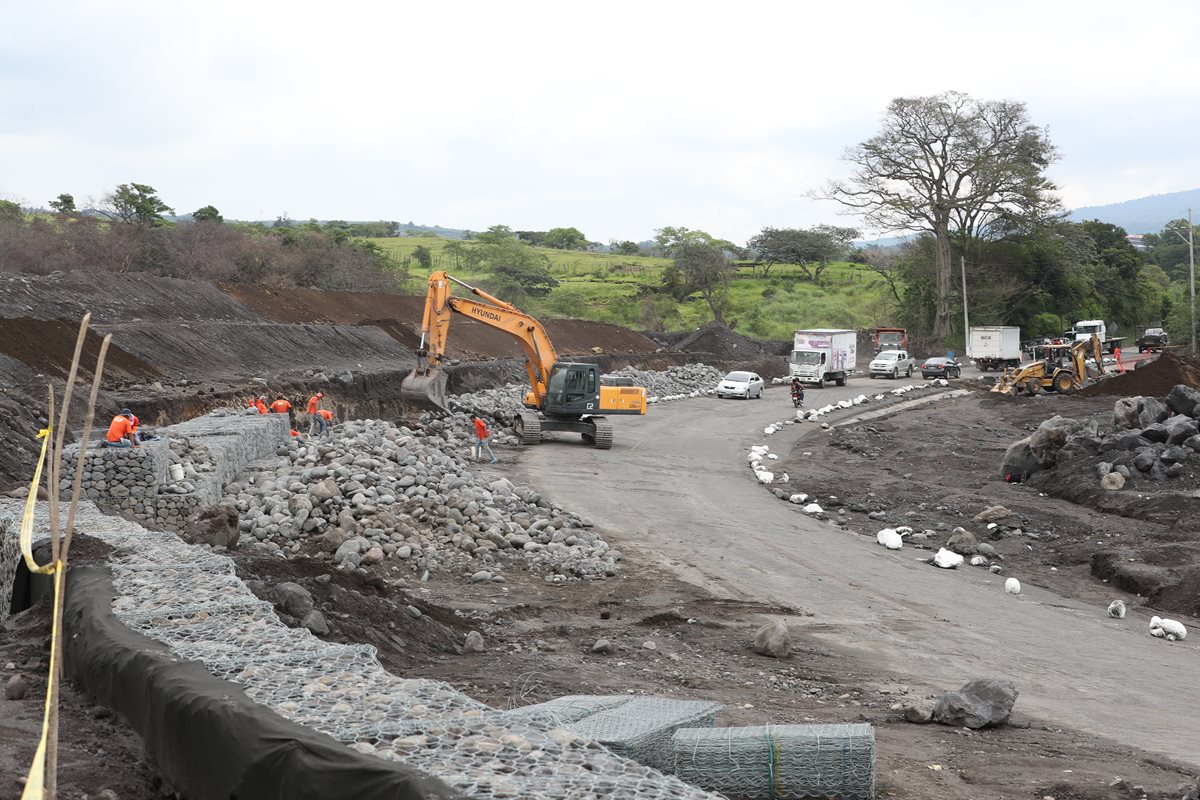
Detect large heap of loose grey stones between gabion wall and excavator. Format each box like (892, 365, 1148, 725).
(223, 417, 620, 583)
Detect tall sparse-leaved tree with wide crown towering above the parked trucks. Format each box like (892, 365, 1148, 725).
(818, 91, 1058, 336)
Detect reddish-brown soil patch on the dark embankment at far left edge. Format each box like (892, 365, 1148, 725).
(0, 317, 158, 379)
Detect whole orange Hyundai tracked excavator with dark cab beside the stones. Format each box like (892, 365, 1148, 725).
(400, 272, 647, 450)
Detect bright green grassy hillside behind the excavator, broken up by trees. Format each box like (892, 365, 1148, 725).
(371, 236, 895, 338)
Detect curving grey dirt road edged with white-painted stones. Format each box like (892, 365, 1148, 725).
(520, 379, 1200, 765)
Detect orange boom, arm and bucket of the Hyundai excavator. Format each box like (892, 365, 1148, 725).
(401, 272, 558, 411)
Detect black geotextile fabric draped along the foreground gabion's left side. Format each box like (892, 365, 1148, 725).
(64, 566, 464, 800)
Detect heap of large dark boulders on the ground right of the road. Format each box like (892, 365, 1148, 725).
(1001, 385, 1200, 491)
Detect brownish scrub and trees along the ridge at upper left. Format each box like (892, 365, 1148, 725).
(0, 184, 408, 290)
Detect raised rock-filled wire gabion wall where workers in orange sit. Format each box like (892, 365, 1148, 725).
(59, 411, 288, 530)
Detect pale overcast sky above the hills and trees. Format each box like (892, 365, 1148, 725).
(0, 0, 1200, 242)
